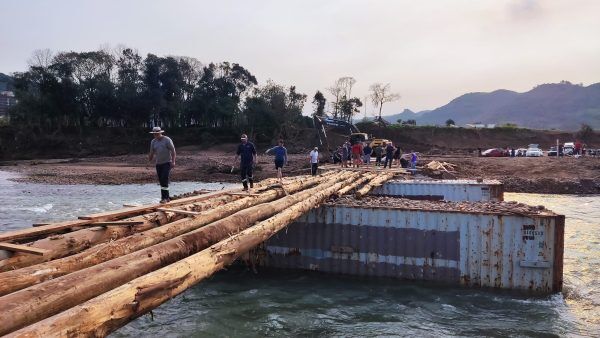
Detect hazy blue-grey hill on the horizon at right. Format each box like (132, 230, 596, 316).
(384, 81, 600, 130)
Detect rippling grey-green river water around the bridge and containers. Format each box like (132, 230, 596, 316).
(0, 172, 600, 337)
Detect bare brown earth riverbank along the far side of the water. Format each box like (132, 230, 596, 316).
(0, 145, 600, 194)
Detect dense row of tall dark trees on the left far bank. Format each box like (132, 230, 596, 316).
(10, 48, 310, 141)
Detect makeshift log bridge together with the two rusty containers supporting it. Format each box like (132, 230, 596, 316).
(0, 168, 564, 337)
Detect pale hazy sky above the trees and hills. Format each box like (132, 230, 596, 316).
(0, 0, 600, 116)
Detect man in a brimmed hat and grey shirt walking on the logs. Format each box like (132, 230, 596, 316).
(148, 127, 177, 203)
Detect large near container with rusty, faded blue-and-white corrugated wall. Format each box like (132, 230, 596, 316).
(259, 205, 564, 293)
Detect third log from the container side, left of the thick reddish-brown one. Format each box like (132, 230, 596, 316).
(0, 172, 340, 295)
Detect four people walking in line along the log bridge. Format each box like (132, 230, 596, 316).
(148, 127, 319, 203)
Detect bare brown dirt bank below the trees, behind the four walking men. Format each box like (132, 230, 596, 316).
(0, 144, 310, 184)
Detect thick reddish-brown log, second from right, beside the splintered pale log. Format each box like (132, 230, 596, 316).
(0, 173, 357, 335)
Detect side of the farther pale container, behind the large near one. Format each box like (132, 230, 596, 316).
(372, 180, 504, 202)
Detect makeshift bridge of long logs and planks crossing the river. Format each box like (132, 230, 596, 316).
(0, 171, 394, 337)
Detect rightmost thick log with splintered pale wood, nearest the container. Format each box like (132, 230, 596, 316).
(7, 172, 358, 337)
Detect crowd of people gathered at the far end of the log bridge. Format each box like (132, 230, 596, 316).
(334, 140, 418, 170)
